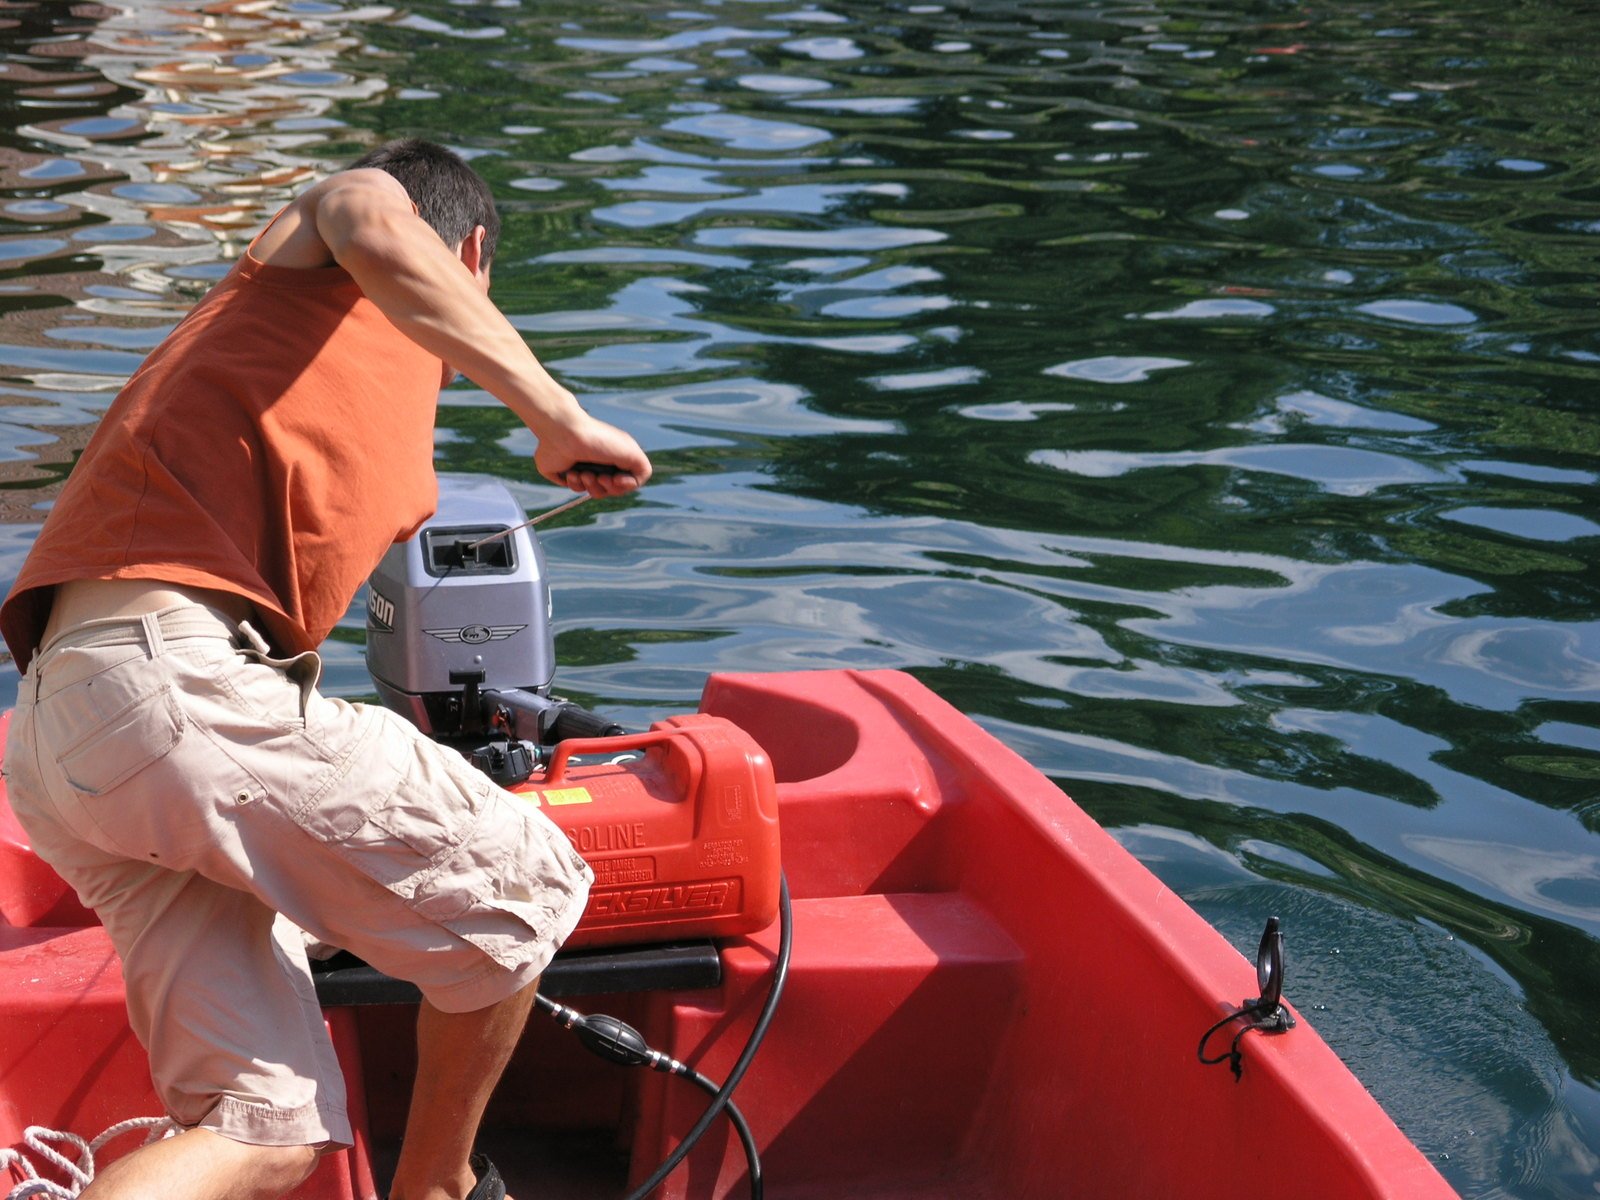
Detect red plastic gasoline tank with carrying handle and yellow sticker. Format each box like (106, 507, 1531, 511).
(515, 714, 781, 947)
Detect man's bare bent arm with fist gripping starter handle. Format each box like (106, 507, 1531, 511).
(293, 170, 651, 496)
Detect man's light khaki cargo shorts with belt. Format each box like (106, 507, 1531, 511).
(5, 605, 594, 1146)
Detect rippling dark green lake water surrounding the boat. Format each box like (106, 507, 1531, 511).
(0, 0, 1600, 1197)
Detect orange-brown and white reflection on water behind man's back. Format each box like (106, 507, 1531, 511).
(0, 2, 396, 508)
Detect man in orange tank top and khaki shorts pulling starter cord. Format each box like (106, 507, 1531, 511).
(0, 141, 650, 1200)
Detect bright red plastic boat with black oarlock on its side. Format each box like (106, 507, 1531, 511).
(0, 672, 1454, 1200)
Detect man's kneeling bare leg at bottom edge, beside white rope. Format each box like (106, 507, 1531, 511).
(83, 1130, 318, 1200)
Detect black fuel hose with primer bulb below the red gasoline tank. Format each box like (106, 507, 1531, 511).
(533, 875, 794, 1200)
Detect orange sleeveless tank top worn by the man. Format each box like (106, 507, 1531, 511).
(0, 240, 442, 670)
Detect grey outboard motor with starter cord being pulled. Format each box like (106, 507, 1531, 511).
(366, 475, 624, 787)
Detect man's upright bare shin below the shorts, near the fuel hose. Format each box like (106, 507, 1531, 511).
(389, 981, 539, 1200)
